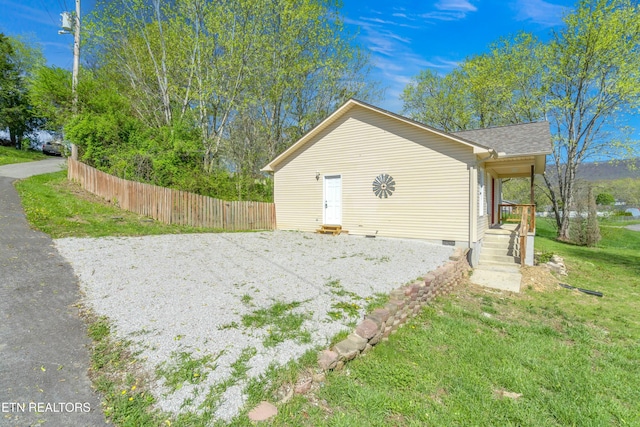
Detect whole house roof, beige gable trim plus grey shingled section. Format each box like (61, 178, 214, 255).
(261, 98, 551, 172)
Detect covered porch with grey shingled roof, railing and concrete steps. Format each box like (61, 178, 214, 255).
(457, 122, 551, 292)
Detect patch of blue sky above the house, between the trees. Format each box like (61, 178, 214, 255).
(343, 0, 574, 112)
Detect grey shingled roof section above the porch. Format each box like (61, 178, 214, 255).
(453, 122, 552, 157)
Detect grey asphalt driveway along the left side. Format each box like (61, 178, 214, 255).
(0, 158, 105, 427)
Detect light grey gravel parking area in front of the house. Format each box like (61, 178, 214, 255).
(55, 231, 453, 420)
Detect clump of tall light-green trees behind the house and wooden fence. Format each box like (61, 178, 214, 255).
(79, 0, 374, 184)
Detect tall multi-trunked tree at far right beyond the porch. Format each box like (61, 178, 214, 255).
(544, 0, 640, 239)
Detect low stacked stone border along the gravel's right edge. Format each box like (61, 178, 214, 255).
(318, 248, 471, 371)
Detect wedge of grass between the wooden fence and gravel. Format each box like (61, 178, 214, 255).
(16, 171, 225, 238)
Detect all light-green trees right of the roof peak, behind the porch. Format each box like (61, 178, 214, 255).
(403, 0, 640, 239)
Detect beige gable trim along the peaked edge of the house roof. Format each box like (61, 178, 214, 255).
(261, 98, 494, 172)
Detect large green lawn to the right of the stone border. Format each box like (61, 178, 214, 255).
(246, 221, 640, 426)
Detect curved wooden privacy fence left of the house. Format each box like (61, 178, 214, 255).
(67, 158, 276, 231)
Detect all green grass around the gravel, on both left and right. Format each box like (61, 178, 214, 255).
(11, 172, 640, 426)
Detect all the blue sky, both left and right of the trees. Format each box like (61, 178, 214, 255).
(0, 0, 574, 112)
